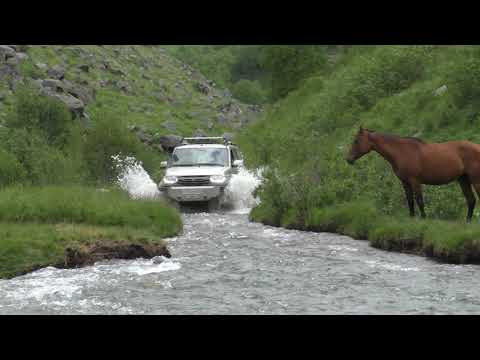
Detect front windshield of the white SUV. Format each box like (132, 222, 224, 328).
(170, 148, 228, 166)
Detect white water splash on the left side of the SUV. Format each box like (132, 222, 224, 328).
(112, 155, 161, 199)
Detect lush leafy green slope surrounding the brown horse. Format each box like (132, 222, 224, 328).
(239, 46, 480, 261)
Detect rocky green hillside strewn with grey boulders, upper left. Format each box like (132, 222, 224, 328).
(0, 45, 261, 150)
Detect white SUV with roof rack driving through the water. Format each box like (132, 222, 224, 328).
(158, 137, 243, 210)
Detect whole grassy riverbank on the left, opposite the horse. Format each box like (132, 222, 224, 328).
(0, 186, 182, 278)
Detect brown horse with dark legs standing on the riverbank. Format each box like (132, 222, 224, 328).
(346, 127, 480, 221)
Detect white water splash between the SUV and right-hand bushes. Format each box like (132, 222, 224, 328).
(225, 168, 262, 213)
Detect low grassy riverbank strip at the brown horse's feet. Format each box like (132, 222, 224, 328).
(250, 203, 480, 264)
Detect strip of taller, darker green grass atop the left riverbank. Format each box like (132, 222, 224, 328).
(0, 186, 182, 237)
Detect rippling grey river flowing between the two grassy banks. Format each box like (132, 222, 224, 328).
(0, 162, 480, 314)
